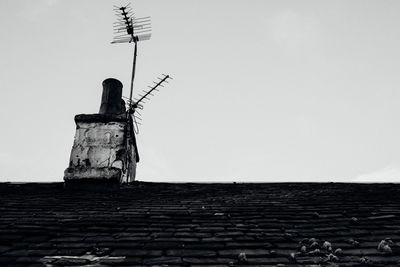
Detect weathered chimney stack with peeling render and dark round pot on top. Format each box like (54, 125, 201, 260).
(64, 78, 136, 183)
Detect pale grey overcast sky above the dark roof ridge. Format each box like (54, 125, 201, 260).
(0, 0, 400, 182)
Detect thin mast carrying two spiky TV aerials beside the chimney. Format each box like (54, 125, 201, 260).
(111, 4, 172, 133)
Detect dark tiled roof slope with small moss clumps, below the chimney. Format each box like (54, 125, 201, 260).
(0, 182, 400, 266)
